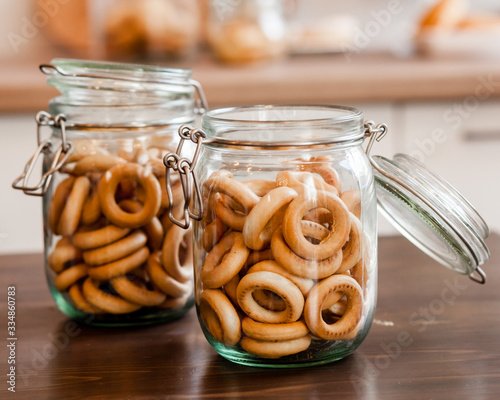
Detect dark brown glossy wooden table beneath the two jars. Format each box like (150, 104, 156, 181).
(0, 235, 500, 400)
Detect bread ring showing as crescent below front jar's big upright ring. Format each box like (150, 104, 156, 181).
(271, 228, 342, 279)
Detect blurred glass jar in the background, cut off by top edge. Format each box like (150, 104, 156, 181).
(207, 0, 287, 63)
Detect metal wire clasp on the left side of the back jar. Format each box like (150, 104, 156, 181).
(12, 111, 72, 196)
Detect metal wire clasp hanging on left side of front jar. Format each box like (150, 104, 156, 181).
(163, 125, 207, 229)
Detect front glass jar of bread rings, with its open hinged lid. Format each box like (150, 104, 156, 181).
(165, 106, 488, 367)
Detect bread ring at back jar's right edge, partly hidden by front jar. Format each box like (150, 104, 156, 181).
(161, 225, 193, 282)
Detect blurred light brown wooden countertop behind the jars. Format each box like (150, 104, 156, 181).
(0, 53, 500, 113)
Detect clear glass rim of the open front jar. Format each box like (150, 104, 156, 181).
(202, 105, 364, 146)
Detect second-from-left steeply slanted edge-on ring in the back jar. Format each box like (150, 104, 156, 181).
(57, 176, 91, 236)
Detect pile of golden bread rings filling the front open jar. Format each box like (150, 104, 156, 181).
(197, 157, 368, 358)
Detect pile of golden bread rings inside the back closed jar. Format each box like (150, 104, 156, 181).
(47, 146, 192, 314)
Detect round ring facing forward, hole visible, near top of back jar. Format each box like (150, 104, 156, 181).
(99, 163, 161, 228)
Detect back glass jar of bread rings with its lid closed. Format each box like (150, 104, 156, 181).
(13, 59, 204, 326)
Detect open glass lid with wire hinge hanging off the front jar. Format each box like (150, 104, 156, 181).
(365, 121, 489, 284)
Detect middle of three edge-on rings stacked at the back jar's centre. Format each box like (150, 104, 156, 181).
(83, 229, 148, 265)
